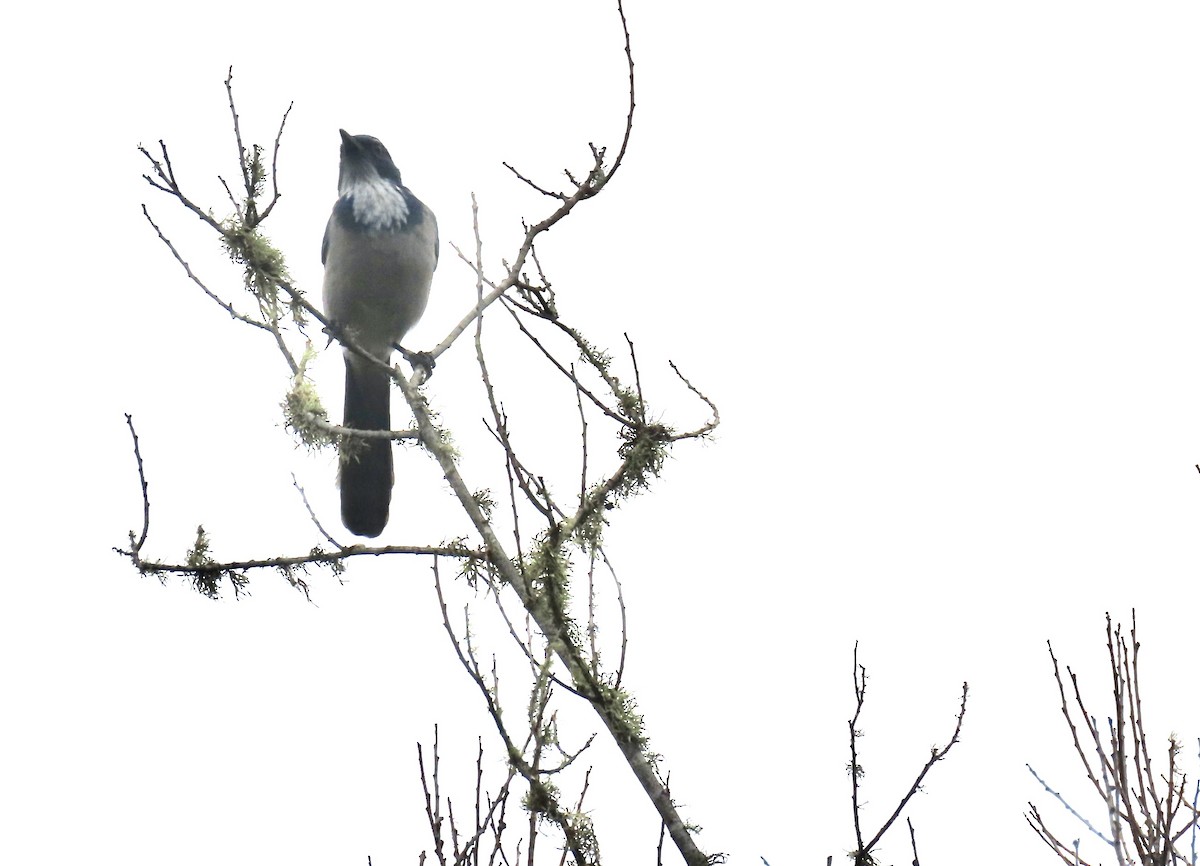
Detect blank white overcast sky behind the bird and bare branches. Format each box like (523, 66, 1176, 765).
(0, 0, 1200, 866)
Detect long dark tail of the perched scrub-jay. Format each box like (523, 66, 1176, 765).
(338, 359, 394, 539)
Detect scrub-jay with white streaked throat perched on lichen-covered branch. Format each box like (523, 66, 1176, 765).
(320, 130, 438, 537)
